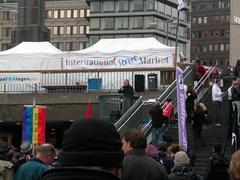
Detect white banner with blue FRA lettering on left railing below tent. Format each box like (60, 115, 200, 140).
(0, 73, 41, 84)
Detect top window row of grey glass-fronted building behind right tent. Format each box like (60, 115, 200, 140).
(90, 0, 186, 21)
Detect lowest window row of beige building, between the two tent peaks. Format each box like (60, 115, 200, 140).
(52, 42, 88, 51)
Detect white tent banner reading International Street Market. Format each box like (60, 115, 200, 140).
(61, 54, 174, 69)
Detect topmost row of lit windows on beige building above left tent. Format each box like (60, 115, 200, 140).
(46, 9, 90, 19)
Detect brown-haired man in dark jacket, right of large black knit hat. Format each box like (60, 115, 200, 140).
(122, 129, 168, 180)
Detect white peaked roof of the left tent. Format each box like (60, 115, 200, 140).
(0, 42, 62, 55)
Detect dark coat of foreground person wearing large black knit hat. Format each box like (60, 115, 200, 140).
(41, 167, 120, 180)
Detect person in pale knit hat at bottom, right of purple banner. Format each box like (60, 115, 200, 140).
(168, 151, 203, 180)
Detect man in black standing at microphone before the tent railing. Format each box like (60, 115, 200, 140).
(118, 79, 134, 114)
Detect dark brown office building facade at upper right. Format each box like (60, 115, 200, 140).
(191, 0, 230, 66)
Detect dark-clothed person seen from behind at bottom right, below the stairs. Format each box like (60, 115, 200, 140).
(206, 144, 229, 180)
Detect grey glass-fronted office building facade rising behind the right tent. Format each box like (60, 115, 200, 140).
(89, 0, 189, 54)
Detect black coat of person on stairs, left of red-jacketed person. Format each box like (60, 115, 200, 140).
(149, 106, 164, 128)
